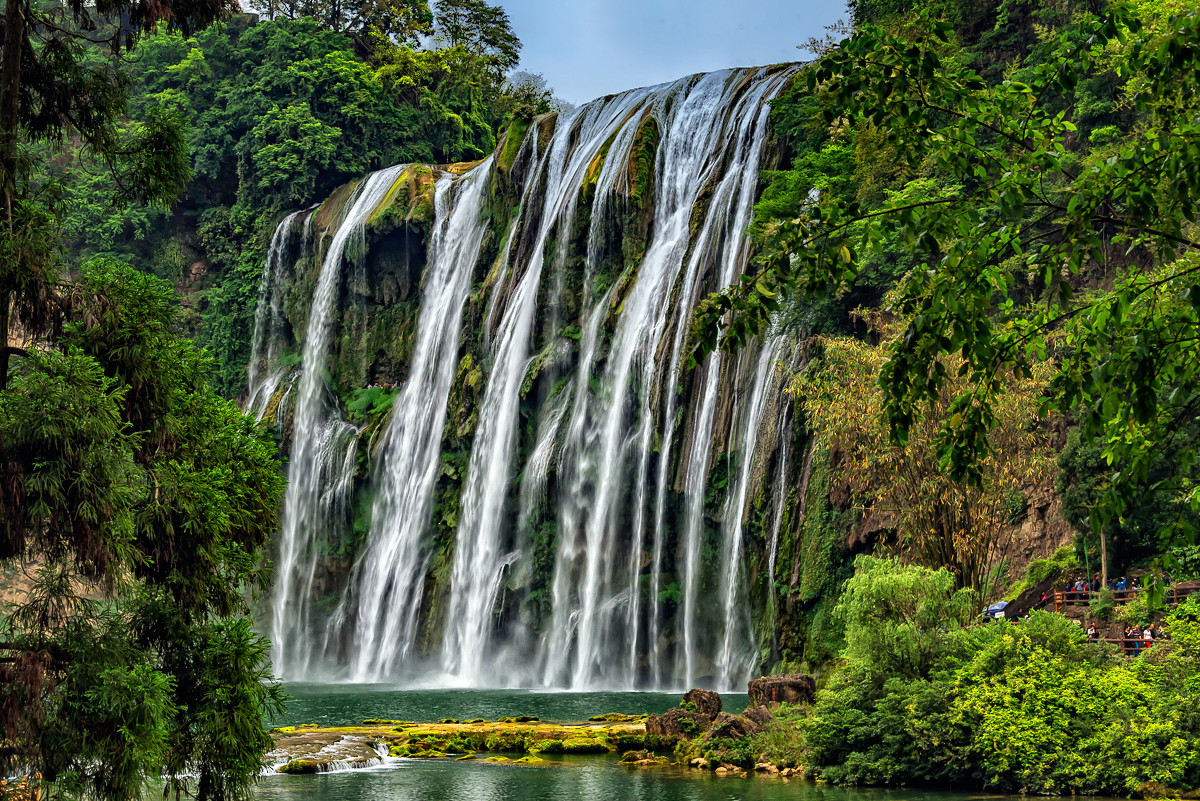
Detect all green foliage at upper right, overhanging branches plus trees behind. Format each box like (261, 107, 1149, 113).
(697, 2, 1200, 582)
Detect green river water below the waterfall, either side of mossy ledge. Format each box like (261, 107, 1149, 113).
(254, 683, 1108, 801)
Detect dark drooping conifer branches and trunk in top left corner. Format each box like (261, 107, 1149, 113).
(0, 0, 229, 390)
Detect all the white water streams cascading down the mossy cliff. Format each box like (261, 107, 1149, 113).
(256, 67, 811, 690)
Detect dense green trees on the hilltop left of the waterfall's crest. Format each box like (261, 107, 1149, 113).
(43, 16, 540, 395)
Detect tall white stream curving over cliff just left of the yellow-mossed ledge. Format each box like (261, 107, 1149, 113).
(271, 165, 403, 679)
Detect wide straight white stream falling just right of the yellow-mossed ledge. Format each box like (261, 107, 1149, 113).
(350, 159, 491, 681)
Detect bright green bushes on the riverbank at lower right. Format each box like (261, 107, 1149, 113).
(799, 558, 1200, 795)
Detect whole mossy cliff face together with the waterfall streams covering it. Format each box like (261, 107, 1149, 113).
(248, 68, 1075, 688)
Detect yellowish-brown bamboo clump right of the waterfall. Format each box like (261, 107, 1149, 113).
(790, 318, 1054, 601)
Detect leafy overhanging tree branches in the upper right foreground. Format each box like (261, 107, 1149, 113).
(696, 2, 1200, 563)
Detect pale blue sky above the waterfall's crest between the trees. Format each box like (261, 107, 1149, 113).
(501, 0, 848, 103)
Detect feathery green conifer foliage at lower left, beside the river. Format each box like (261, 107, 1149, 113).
(0, 260, 282, 799)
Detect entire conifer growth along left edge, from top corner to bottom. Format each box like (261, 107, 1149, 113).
(0, 0, 289, 786)
